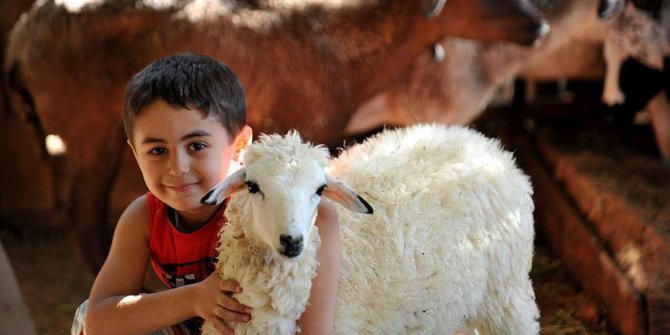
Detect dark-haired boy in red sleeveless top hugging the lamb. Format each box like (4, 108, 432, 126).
(73, 54, 340, 335)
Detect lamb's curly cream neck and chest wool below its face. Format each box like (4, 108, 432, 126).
(218, 199, 320, 321)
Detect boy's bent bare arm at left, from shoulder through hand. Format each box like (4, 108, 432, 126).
(85, 196, 248, 335)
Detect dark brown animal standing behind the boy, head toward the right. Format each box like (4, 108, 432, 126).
(5, 0, 546, 270)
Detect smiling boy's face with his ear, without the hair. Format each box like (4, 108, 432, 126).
(130, 100, 250, 221)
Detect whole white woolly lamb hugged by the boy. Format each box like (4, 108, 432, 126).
(203, 125, 539, 335)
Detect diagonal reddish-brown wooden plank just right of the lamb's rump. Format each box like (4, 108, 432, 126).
(515, 137, 646, 335)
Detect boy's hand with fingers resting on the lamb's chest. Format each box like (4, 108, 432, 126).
(194, 272, 251, 335)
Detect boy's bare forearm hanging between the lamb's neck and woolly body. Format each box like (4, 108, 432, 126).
(298, 201, 342, 335)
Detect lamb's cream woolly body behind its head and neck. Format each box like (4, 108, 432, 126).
(330, 125, 538, 334)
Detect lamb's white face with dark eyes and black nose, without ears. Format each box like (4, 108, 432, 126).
(245, 160, 326, 257)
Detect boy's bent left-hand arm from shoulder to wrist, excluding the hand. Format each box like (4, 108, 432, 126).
(85, 196, 193, 334)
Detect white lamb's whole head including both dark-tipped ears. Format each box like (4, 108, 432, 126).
(202, 131, 372, 257)
